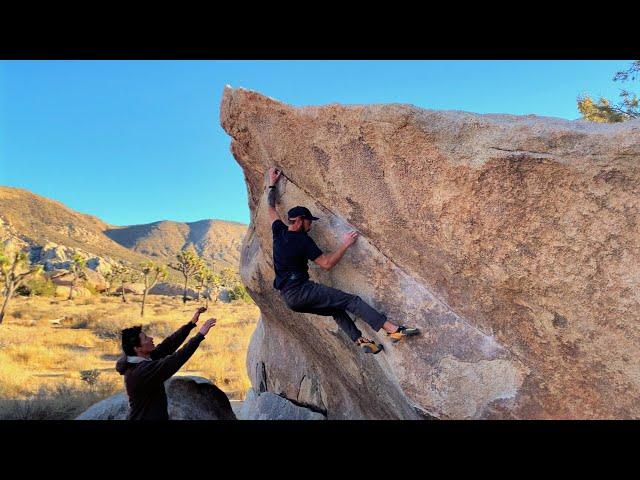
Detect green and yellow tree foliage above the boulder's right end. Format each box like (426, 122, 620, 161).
(578, 60, 640, 123)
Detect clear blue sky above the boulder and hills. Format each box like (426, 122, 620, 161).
(0, 60, 630, 225)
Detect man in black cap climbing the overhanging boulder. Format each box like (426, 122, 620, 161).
(268, 167, 419, 354)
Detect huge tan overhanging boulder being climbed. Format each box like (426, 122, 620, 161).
(220, 88, 640, 419)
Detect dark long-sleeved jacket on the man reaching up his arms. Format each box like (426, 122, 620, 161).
(116, 322, 204, 420)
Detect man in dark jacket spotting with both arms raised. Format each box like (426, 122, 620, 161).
(116, 307, 216, 420)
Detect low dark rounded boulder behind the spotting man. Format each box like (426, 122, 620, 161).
(76, 377, 236, 420)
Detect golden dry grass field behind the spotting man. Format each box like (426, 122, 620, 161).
(0, 295, 259, 418)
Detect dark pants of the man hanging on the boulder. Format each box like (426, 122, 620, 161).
(281, 280, 387, 342)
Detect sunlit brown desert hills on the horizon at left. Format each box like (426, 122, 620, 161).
(0, 187, 247, 276)
